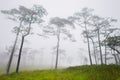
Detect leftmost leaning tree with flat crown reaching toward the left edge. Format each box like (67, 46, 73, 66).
(1, 8, 26, 74)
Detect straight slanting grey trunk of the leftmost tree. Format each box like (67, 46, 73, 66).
(6, 21, 22, 75)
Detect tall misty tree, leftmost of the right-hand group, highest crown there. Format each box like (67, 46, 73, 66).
(69, 8, 93, 65)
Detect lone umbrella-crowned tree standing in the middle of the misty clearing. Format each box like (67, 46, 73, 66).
(43, 17, 74, 69)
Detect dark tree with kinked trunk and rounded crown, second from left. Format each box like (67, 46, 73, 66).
(16, 5, 47, 73)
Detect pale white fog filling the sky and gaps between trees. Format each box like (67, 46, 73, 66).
(0, 0, 120, 72)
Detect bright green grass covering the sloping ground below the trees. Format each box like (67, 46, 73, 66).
(0, 65, 120, 80)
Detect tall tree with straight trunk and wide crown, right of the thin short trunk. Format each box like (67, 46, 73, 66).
(91, 15, 116, 64)
